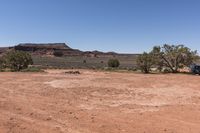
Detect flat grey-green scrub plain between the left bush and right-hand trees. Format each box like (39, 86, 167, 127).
(32, 54, 137, 69)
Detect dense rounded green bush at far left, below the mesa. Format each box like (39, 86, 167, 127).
(2, 50, 33, 71)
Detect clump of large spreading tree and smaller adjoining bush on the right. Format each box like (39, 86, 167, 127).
(137, 44, 198, 73)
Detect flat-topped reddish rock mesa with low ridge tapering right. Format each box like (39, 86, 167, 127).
(0, 43, 118, 57)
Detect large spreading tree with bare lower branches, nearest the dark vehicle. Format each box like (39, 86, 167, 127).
(151, 44, 198, 73)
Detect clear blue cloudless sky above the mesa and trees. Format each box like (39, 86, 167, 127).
(0, 0, 200, 53)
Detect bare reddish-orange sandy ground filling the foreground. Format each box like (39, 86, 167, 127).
(0, 70, 200, 133)
